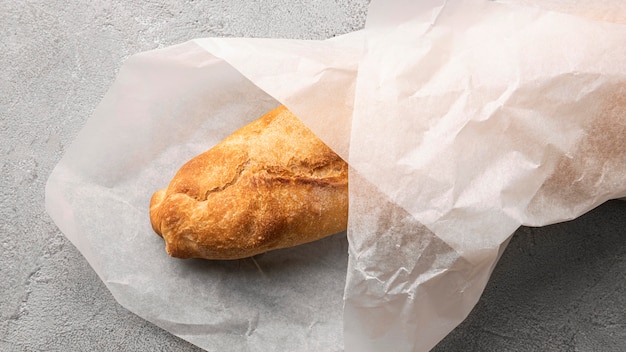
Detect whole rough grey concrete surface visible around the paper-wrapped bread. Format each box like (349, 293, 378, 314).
(0, 0, 626, 352)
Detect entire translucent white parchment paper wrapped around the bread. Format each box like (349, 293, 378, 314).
(46, 0, 626, 351)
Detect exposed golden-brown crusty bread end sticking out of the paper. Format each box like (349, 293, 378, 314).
(150, 106, 348, 259)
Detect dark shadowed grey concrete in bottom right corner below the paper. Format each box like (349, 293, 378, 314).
(436, 201, 626, 352)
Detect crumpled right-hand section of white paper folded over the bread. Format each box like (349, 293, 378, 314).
(344, 1, 626, 351)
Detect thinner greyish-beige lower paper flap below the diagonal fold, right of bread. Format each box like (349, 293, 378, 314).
(344, 172, 500, 351)
